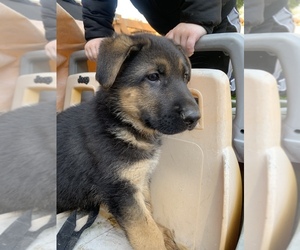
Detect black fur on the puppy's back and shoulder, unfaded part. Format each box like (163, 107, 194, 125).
(57, 99, 156, 212)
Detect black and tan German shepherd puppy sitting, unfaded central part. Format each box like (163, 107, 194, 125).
(57, 34, 200, 250)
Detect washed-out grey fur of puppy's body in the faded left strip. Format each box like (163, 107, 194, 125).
(0, 102, 56, 213)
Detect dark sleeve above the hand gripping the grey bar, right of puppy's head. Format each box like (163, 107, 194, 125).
(180, 0, 224, 34)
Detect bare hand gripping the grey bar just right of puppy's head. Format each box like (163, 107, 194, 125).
(166, 23, 207, 56)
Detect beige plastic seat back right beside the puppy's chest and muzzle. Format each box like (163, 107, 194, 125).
(151, 69, 242, 250)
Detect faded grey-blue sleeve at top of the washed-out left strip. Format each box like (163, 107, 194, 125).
(40, 0, 56, 41)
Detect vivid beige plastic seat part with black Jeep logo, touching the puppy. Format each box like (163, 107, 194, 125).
(64, 72, 100, 109)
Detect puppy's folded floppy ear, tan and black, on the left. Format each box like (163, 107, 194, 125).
(96, 35, 150, 89)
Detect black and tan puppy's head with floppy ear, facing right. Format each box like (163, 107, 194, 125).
(96, 34, 200, 134)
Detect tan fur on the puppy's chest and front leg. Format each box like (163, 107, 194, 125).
(119, 154, 185, 250)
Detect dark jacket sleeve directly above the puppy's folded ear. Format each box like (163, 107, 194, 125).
(82, 0, 117, 41)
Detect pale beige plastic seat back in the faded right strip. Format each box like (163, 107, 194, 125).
(244, 70, 297, 250)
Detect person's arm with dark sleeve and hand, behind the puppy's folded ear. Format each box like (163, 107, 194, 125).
(82, 0, 117, 61)
